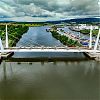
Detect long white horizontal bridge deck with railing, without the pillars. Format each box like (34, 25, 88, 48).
(0, 47, 100, 52)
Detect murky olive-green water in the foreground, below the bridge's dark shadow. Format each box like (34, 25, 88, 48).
(0, 61, 100, 100)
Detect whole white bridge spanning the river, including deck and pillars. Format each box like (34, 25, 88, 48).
(0, 24, 100, 53)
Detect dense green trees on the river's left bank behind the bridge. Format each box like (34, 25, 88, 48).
(0, 25, 29, 46)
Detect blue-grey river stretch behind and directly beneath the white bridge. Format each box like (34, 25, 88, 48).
(13, 26, 85, 59)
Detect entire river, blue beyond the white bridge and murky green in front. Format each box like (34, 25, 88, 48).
(0, 27, 100, 100)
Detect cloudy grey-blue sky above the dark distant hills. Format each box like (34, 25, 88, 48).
(0, 0, 99, 21)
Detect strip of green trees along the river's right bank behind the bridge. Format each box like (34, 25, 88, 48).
(51, 30, 81, 46)
